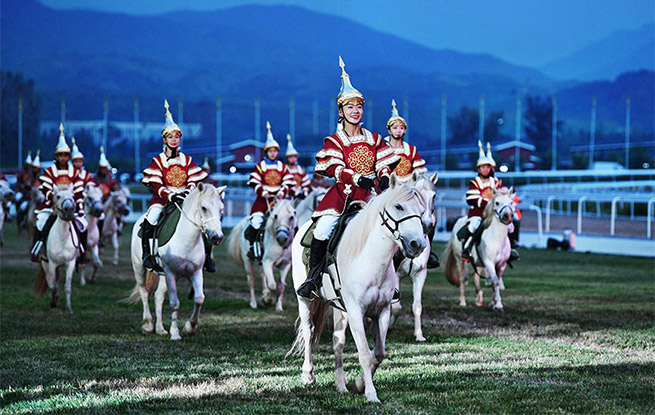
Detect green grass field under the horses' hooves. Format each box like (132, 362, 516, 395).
(0, 224, 655, 414)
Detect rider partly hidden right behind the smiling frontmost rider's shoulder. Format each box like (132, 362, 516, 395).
(384, 99, 439, 268)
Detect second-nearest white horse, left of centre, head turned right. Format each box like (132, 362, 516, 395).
(126, 183, 226, 340)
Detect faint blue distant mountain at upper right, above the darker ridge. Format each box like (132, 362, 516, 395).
(541, 23, 655, 81)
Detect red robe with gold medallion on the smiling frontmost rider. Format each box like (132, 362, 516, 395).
(312, 128, 398, 219)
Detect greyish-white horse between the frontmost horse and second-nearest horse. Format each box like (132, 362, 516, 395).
(228, 200, 297, 311)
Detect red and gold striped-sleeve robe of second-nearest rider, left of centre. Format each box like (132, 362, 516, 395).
(141, 152, 207, 205)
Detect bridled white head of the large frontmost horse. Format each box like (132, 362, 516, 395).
(378, 173, 427, 258)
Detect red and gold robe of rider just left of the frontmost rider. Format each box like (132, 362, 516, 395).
(248, 160, 295, 215)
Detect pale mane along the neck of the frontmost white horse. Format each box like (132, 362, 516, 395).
(340, 185, 415, 258)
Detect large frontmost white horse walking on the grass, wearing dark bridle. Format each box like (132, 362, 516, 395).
(289, 174, 427, 402)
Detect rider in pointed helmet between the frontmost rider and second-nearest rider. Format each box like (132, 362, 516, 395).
(244, 122, 295, 259)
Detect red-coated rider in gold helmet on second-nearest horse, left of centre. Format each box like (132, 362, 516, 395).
(141, 100, 216, 272)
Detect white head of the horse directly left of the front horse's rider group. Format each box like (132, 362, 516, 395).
(193, 183, 227, 245)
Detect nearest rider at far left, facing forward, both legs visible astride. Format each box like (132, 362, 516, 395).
(30, 124, 89, 264)
